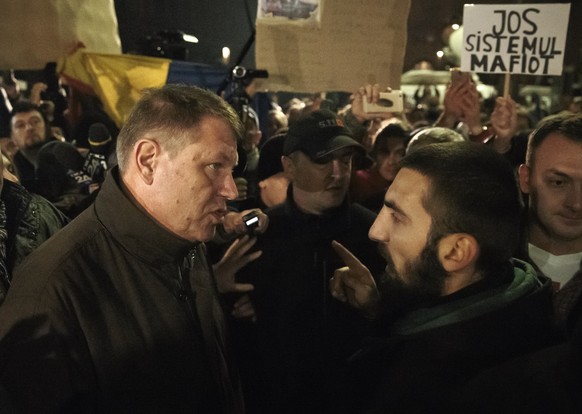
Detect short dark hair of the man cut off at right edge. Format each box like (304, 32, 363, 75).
(525, 112, 582, 168)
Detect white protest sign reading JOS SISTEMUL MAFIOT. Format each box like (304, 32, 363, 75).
(461, 4, 570, 76)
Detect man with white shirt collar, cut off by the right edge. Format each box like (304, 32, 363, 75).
(519, 113, 582, 335)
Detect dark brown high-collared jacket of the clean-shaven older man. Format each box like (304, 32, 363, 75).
(0, 169, 244, 413)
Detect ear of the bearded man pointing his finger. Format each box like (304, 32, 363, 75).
(438, 233, 479, 274)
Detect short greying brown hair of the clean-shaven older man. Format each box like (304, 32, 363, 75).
(117, 84, 243, 171)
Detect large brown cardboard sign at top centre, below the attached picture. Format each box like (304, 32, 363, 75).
(255, 0, 410, 93)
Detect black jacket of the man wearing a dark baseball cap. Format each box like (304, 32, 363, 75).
(237, 188, 383, 413)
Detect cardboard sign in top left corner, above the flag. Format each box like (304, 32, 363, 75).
(0, 0, 121, 69)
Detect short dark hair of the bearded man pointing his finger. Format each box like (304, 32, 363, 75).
(401, 142, 523, 275)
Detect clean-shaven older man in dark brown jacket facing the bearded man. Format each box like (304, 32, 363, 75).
(0, 85, 244, 413)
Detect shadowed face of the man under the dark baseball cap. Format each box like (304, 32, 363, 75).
(283, 148, 354, 215)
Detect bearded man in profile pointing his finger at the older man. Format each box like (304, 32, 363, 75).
(331, 142, 551, 413)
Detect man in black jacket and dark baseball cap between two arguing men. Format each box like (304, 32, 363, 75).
(237, 110, 381, 413)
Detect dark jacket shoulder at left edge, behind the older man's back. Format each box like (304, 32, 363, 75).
(0, 180, 69, 304)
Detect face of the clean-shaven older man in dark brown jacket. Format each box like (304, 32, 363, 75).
(144, 116, 238, 241)
